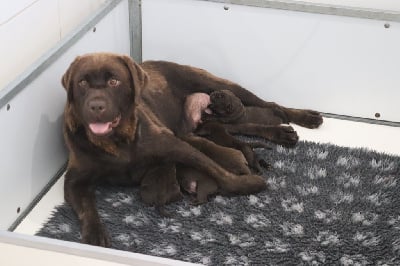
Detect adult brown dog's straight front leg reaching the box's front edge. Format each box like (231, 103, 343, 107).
(64, 169, 111, 247)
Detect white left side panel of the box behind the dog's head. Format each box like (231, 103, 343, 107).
(0, 1, 130, 229)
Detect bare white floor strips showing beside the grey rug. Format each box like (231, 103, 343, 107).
(15, 118, 400, 235)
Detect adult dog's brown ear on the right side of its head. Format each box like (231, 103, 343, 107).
(120, 55, 149, 102)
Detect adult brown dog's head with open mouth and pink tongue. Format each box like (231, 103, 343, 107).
(62, 53, 148, 137)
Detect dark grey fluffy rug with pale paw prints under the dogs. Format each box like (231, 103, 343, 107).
(38, 142, 400, 265)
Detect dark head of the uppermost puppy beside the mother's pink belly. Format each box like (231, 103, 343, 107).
(208, 90, 245, 122)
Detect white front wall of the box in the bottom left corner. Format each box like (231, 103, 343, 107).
(0, 230, 199, 266)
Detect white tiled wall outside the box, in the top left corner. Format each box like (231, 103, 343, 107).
(0, 0, 106, 90)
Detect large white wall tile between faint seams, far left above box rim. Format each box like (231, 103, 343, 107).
(0, 0, 60, 89)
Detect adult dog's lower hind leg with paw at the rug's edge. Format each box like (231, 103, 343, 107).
(224, 123, 299, 147)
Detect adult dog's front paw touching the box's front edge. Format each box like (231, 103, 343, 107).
(82, 220, 111, 247)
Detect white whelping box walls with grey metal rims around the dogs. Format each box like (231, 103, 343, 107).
(0, 0, 400, 265)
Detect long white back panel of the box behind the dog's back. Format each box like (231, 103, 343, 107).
(143, 0, 400, 121)
